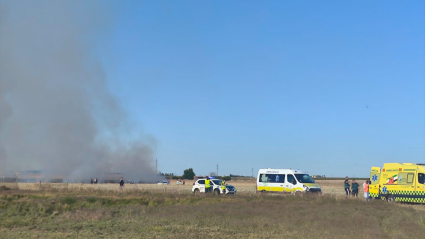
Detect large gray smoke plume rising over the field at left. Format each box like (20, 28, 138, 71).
(0, 1, 157, 181)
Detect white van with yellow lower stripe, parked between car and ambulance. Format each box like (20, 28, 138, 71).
(257, 168, 322, 193)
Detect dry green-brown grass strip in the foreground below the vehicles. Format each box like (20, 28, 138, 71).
(0, 190, 425, 238)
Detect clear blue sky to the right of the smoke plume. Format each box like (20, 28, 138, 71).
(100, 1, 425, 177)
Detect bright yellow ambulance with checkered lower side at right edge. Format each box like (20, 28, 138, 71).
(369, 163, 425, 203)
